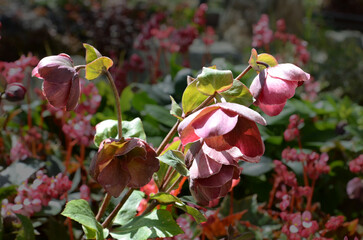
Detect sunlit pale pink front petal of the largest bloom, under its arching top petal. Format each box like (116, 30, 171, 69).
(191, 109, 238, 138)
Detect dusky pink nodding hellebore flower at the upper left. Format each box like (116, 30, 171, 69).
(32, 53, 80, 111)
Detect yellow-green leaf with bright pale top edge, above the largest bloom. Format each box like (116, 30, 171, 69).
(197, 67, 233, 96)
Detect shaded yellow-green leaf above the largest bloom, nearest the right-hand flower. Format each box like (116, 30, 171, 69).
(221, 80, 254, 107)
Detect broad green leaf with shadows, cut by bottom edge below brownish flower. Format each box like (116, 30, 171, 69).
(110, 209, 184, 240)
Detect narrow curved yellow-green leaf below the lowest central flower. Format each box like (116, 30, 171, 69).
(150, 193, 207, 224)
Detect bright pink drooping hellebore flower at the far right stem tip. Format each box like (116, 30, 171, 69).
(250, 63, 310, 116)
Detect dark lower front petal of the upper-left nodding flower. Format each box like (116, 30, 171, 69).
(43, 81, 71, 108)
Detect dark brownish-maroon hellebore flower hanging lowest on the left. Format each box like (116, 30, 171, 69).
(90, 138, 159, 197)
